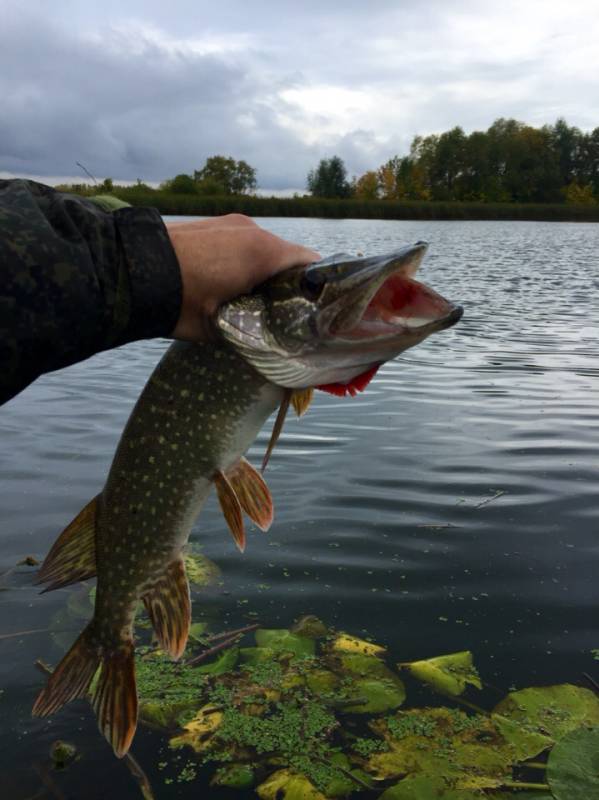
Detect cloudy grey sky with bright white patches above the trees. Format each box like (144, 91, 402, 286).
(0, 0, 599, 190)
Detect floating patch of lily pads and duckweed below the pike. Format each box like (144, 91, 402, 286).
(131, 618, 599, 800)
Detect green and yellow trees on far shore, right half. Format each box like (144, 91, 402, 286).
(314, 119, 599, 204)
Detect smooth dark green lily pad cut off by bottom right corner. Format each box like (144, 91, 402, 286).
(547, 727, 599, 800)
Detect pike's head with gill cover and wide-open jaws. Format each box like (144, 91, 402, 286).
(217, 242, 463, 393)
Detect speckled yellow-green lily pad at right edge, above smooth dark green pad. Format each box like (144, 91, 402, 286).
(493, 683, 599, 741)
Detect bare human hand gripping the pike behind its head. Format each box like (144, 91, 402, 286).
(166, 214, 320, 341)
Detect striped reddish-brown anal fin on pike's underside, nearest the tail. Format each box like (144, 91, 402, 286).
(143, 558, 191, 659)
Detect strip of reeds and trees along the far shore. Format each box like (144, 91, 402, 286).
(60, 119, 599, 221)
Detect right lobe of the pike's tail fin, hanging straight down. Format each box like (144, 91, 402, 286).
(92, 640, 137, 758)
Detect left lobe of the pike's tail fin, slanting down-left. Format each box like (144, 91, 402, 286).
(32, 622, 101, 717)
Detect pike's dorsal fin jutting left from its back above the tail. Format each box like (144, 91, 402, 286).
(36, 495, 100, 592)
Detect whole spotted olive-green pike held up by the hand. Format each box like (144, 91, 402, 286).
(33, 242, 462, 757)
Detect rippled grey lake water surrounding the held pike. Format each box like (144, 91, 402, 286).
(0, 219, 599, 800)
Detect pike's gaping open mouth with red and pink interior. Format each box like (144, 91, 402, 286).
(332, 247, 463, 340)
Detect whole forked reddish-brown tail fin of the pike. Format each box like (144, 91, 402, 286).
(32, 620, 137, 758)
